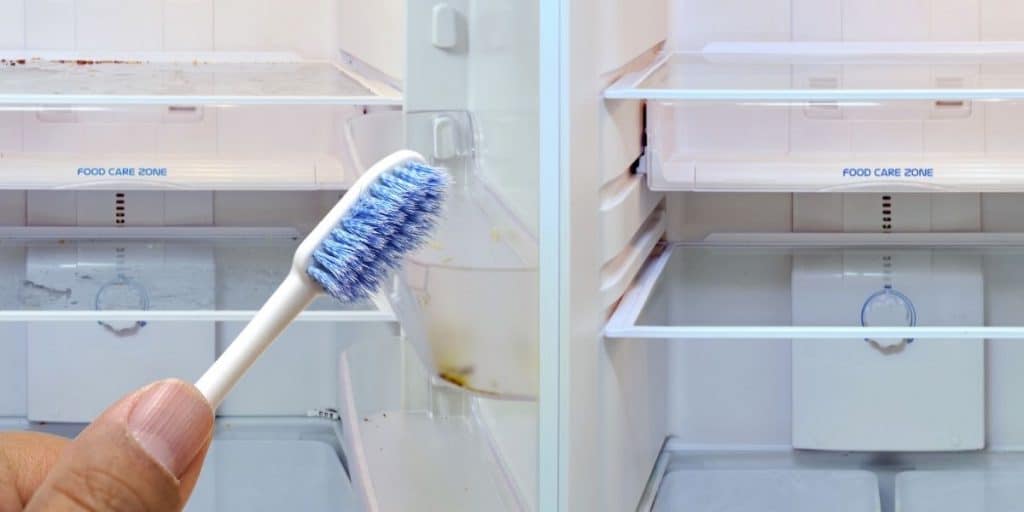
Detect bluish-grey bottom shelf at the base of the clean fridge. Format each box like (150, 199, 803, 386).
(637, 438, 1024, 512)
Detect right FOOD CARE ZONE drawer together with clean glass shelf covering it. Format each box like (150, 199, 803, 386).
(605, 43, 1024, 193)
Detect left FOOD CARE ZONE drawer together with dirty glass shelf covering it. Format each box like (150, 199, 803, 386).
(0, 52, 401, 190)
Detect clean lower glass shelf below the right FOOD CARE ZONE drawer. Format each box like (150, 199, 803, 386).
(605, 233, 1024, 339)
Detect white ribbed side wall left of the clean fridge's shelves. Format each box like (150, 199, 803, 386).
(561, 0, 669, 512)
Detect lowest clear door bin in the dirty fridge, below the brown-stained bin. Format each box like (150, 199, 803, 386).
(338, 338, 537, 511)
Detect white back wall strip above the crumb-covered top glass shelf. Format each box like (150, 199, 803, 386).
(0, 0, 344, 59)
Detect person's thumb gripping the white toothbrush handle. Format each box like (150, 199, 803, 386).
(26, 380, 213, 512)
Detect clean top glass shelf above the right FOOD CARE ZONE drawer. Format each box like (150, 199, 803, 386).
(604, 42, 1024, 101)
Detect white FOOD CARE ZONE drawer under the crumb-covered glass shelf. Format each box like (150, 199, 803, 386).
(0, 98, 380, 190)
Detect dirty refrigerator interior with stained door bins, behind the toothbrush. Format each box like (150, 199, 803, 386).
(0, 0, 538, 511)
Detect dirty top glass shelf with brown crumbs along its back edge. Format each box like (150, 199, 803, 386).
(0, 52, 401, 106)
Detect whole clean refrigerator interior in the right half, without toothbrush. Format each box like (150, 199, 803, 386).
(585, 0, 1024, 512)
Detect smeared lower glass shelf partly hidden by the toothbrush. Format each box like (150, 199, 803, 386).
(0, 228, 394, 322)
